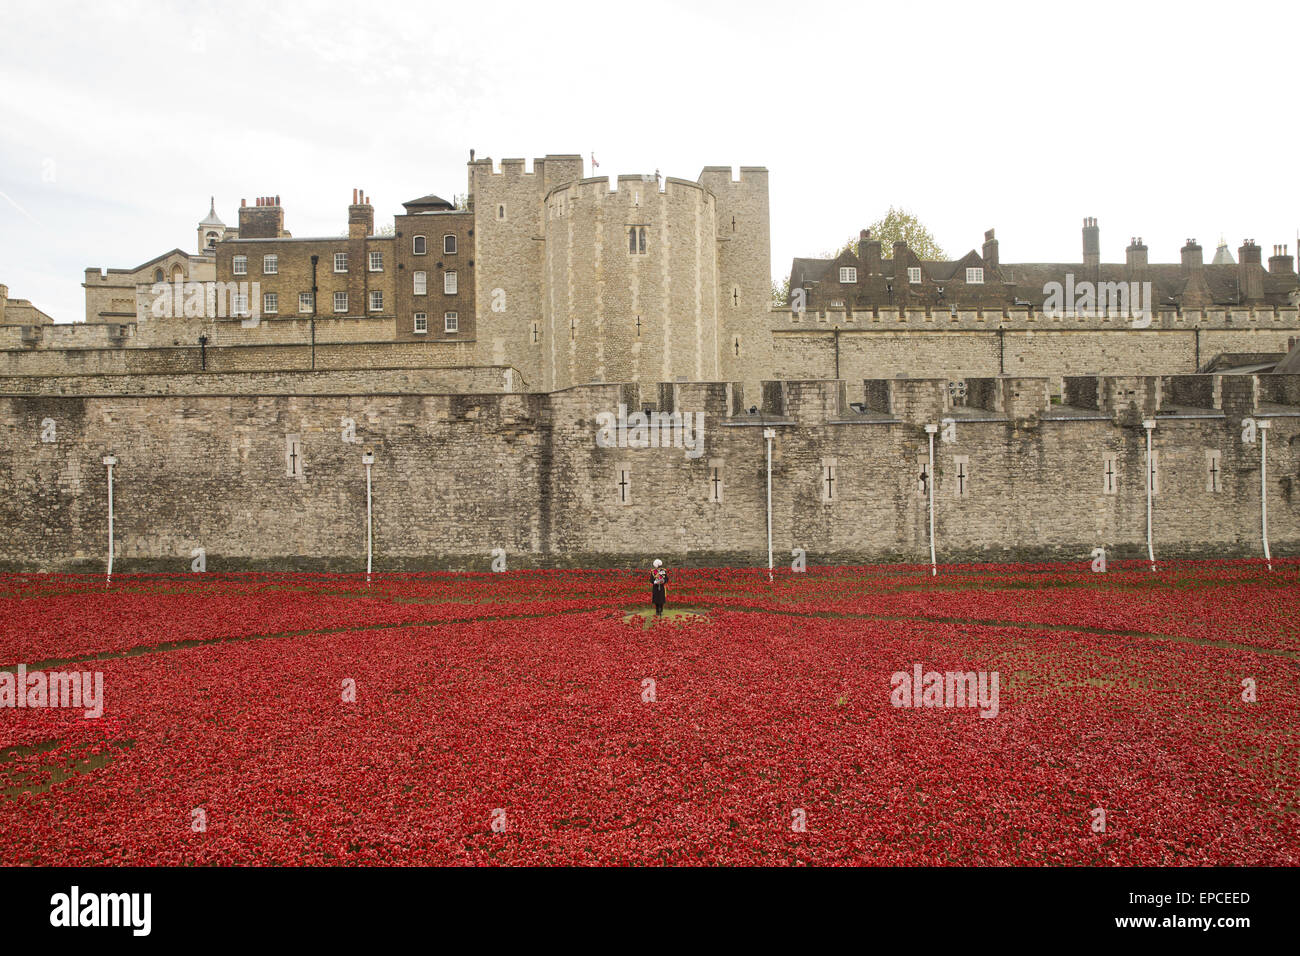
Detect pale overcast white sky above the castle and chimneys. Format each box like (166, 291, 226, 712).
(0, 0, 1300, 321)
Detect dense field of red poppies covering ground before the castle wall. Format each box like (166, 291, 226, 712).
(0, 561, 1300, 865)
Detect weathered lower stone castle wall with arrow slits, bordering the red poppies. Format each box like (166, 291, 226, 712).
(0, 376, 1300, 571)
